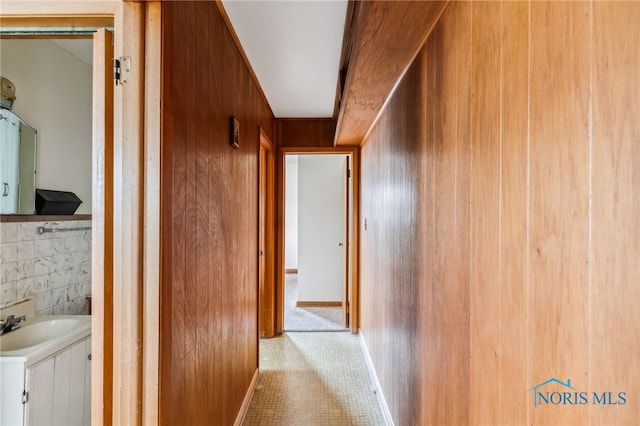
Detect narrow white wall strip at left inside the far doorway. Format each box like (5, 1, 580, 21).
(284, 155, 298, 269)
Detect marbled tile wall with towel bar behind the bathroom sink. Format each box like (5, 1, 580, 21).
(0, 220, 91, 315)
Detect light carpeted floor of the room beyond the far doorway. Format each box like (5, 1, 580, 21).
(284, 274, 348, 331)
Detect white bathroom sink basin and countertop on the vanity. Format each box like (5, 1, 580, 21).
(0, 315, 91, 356)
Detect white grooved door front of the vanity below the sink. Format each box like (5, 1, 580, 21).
(24, 338, 91, 425)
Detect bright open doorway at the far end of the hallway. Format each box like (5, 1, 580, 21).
(284, 153, 351, 331)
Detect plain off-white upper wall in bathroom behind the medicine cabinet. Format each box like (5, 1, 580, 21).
(0, 39, 92, 213)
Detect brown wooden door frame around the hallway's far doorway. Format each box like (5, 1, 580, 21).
(274, 146, 360, 335)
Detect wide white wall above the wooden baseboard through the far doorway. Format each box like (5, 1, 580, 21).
(298, 155, 346, 302)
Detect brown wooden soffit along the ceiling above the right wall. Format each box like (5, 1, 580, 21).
(334, 0, 449, 146)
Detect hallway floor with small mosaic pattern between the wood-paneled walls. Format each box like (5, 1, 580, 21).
(244, 332, 385, 426)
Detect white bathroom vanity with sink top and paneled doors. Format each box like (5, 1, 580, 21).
(0, 322, 91, 426)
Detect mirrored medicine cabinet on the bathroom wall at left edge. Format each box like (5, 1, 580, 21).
(0, 109, 38, 214)
